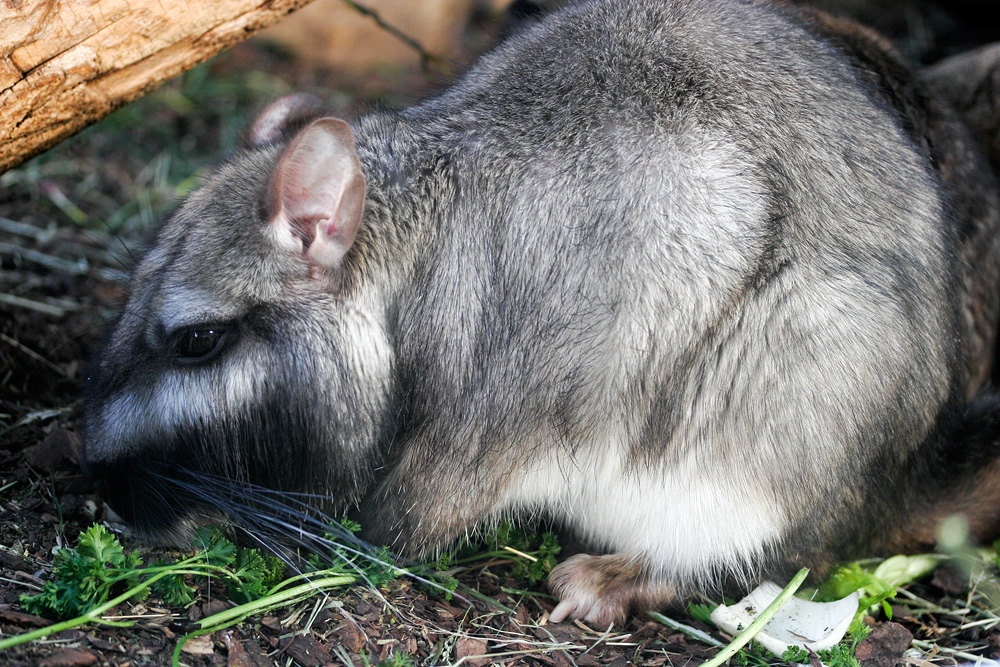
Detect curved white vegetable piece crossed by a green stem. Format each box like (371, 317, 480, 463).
(712, 581, 858, 657)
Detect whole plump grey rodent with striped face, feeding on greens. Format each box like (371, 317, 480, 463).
(84, 0, 1000, 621)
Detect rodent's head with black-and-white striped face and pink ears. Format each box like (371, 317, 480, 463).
(83, 102, 393, 538)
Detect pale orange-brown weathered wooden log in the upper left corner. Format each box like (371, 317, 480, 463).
(0, 0, 310, 173)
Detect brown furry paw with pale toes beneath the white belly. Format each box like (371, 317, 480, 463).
(549, 554, 675, 627)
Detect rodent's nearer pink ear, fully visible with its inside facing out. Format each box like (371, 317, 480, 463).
(270, 118, 365, 269)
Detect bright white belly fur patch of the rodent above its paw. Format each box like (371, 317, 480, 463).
(502, 436, 788, 585)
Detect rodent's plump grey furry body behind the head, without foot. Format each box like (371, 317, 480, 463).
(352, 2, 961, 568)
